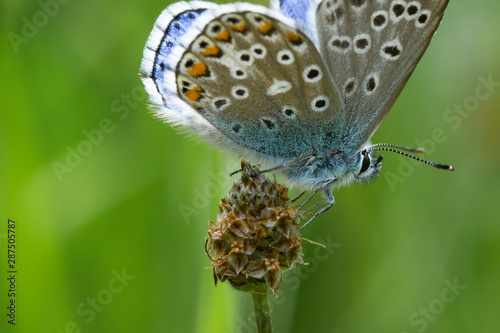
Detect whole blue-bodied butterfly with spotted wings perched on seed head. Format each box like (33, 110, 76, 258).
(140, 0, 453, 227)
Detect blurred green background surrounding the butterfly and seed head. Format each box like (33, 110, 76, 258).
(0, 0, 500, 333)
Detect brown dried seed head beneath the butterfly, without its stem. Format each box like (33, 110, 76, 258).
(206, 161, 304, 293)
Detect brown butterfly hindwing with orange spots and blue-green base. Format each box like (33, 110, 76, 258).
(159, 4, 345, 161)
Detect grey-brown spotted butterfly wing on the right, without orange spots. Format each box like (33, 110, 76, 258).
(310, 0, 448, 152)
